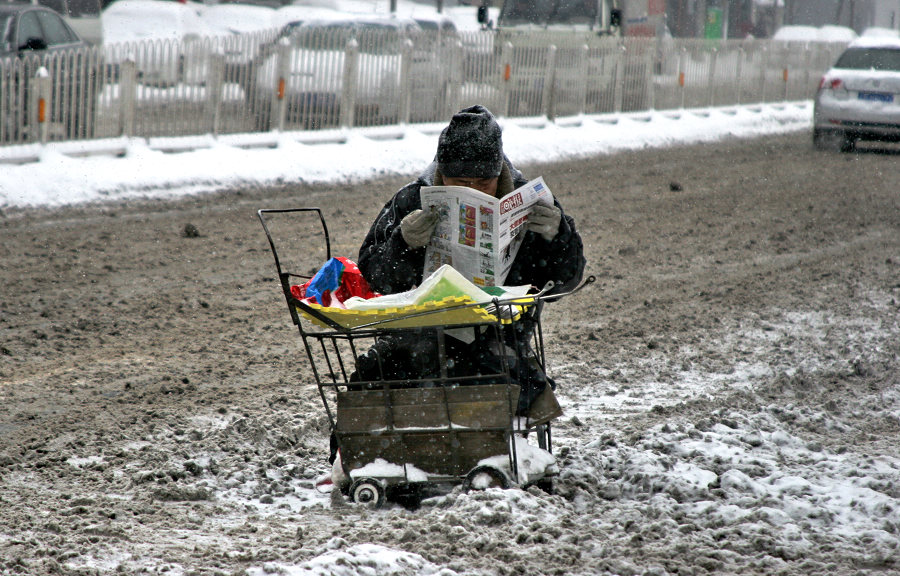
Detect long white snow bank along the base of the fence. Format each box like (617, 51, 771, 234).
(0, 101, 812, 208)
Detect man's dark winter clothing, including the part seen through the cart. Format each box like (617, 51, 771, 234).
(353, 157, 585, 415)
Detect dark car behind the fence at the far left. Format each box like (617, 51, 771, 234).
(0, 3, 101, 141)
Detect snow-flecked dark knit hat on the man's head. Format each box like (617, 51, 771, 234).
(437, 105, 503, 178)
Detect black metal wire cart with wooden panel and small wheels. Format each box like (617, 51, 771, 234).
(258, 208, 594, 506)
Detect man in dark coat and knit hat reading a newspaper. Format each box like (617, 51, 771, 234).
(358, 106, 585, 424)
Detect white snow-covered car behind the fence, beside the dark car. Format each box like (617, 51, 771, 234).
(103, 0, 214, 87)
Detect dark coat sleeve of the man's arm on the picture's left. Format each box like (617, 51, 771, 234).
(357, 180, 425, 294)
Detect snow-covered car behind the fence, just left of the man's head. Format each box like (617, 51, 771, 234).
(253, 17, 433, 130)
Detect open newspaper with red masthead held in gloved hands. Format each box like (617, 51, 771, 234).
(420, 177, 553, 286)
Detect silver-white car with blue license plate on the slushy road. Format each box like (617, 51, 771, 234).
(813, 37, 900, 152)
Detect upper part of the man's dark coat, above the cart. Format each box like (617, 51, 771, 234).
(358, 158, 585, 294)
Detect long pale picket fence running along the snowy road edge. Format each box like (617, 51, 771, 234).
(0, 30, 844, 146)
